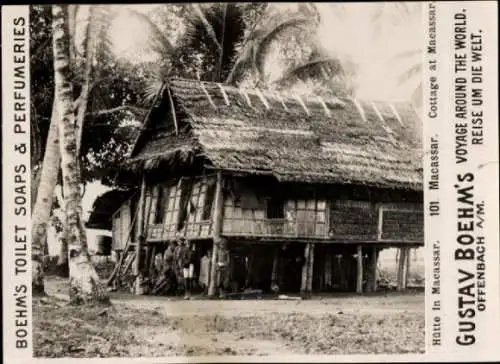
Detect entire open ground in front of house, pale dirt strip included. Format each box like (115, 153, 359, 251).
(33, 277, 424, 357)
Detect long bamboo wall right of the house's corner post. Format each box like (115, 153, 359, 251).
(222, 178, 424, 243)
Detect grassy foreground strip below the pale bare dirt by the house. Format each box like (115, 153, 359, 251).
(33, 297, 424, 358)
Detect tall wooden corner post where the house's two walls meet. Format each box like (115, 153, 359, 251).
(208, 172, 224, 297)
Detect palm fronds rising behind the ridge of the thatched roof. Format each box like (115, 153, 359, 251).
(127, 3, 350, 102)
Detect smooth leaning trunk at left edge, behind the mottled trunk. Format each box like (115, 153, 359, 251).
(31, 100, 60, 295)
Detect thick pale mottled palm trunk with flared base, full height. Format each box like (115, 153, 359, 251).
(52, 5, 109, 304)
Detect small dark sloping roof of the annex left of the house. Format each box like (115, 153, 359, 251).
(85, 190, 134, 230)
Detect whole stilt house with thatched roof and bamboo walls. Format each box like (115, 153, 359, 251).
(108, 79, 424, 294)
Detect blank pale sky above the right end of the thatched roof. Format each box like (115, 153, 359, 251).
(318, 3, 423, 101)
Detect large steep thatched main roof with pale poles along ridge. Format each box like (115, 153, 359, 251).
(131, 79, 422, 190)
